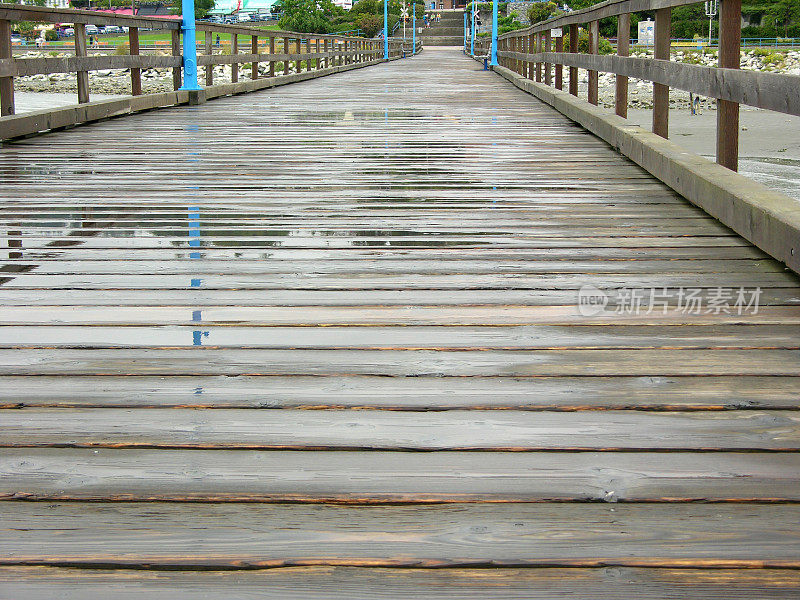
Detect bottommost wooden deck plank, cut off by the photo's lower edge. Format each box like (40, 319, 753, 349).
(0, 567, 800, 600)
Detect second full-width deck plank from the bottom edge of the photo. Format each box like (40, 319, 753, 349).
(0, 502, 800, 569)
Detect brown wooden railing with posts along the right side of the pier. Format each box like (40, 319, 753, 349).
(476, 0, 800, 171)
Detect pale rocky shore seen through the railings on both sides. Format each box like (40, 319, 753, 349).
(14, 48, 800, 109)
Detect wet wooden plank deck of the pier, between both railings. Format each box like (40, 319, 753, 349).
(0, 50, 800, 600)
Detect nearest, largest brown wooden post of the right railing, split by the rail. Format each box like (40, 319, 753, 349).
(717, 0, 742, 171)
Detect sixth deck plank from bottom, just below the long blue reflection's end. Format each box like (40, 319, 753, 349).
(0, 346, 800, 377)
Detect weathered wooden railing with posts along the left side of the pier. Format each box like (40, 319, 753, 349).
(0, 4, 420, 120)
